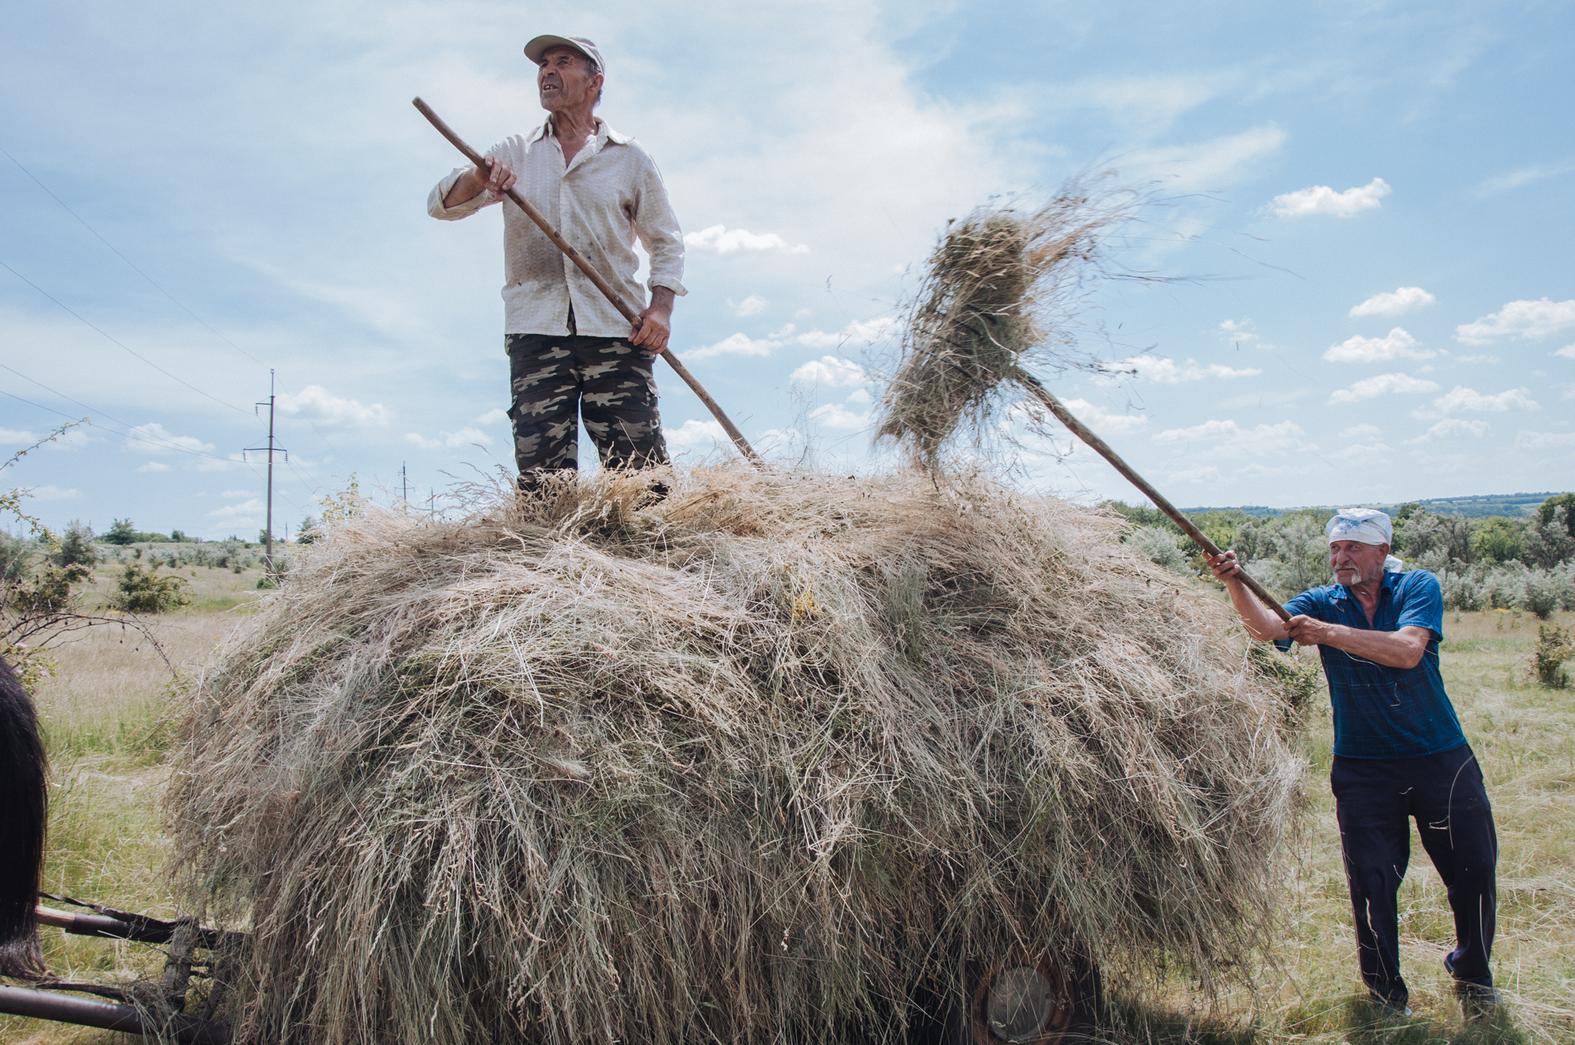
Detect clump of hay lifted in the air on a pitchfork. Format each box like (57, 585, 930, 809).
(876, 183, 1136, 471)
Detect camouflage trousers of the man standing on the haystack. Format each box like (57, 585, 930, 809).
(504, 334, 668, 487)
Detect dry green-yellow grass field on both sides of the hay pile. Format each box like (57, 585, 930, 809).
(0, 567, 1575, 1043)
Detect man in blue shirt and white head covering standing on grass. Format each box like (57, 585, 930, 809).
(1210, 508, 1498, 1018)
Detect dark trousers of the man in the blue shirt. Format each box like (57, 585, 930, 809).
(1329, 746, 1498, 1006)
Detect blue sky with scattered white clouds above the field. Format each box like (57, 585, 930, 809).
(0, 0, 1575, 536)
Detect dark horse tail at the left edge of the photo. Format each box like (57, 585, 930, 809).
(0, 660, 49, 976)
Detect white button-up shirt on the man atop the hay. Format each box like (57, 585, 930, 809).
(427, 120, 685, 337)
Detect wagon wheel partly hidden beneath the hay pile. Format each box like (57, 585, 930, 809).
(964, 955, 1099, 1045)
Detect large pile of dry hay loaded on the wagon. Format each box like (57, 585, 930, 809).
(170, 467, 1301, 1043)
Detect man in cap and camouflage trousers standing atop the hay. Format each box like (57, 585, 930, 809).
(427, 35, 685, 490)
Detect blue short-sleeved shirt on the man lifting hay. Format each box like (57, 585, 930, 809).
(1280, 569, 1466, 758)
